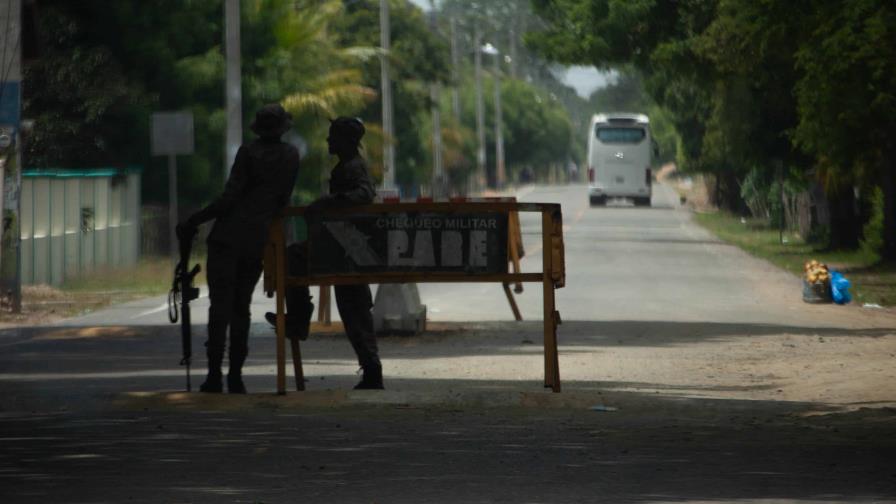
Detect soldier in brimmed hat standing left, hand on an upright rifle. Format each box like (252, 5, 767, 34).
(177, 104, 299, 394)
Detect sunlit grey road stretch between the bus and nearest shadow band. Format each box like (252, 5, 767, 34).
(421, 181, 784, 322)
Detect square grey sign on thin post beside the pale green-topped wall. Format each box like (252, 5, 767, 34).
(152, 112, 193, 260)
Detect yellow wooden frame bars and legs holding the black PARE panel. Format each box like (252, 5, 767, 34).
(264, 201, 566, 394)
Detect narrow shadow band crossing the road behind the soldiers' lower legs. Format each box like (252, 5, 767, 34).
(0, 320, 894, 381)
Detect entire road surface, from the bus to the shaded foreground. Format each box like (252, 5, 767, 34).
(0, 186, 896, 503)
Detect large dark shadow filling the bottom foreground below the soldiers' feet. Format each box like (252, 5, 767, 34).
(0, 381, 896, 503)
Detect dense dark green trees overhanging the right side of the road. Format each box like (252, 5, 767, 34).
(527, 0, 896, 262)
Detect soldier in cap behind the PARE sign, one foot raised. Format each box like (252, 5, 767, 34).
(266, 117, 383, 389)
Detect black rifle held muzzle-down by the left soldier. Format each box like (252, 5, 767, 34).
(168, 232, 201, 392)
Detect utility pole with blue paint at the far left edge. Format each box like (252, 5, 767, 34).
(0, 0, 22, 313)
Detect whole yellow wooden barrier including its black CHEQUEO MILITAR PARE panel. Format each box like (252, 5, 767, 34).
(264, 198, 566, 394)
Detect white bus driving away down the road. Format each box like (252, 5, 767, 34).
(588, 113, 656, 206)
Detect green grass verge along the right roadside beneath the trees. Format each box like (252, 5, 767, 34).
(694, 212, 896, 306)
